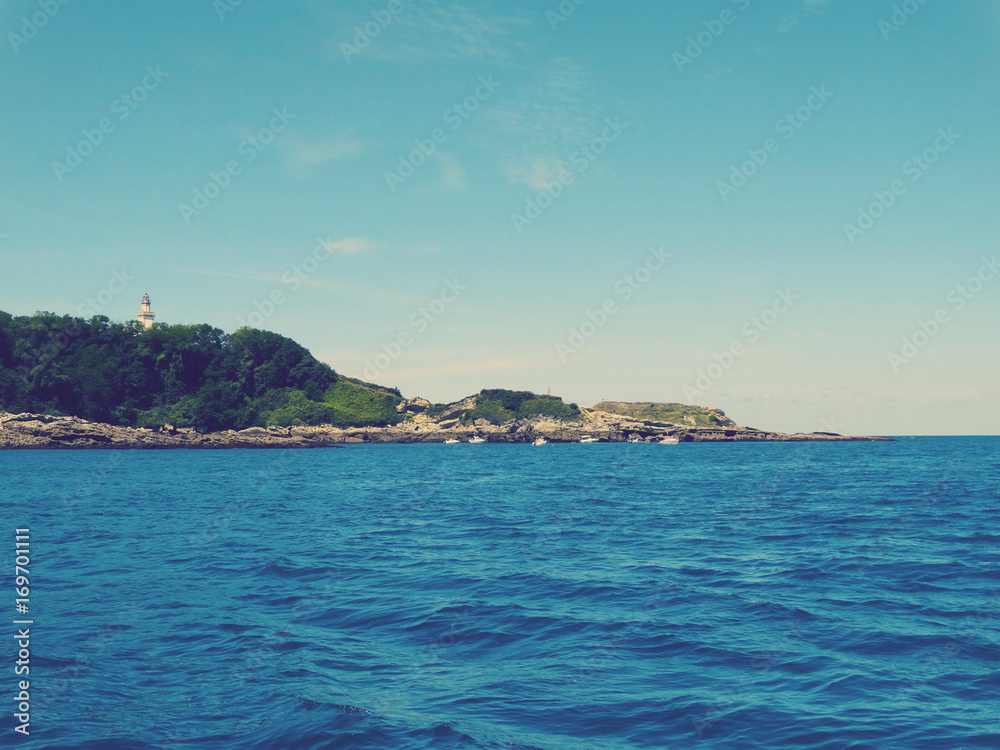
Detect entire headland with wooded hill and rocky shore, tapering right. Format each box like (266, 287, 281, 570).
(0, 312, 892, 448)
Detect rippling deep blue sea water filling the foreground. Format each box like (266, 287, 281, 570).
(0, 438, 1000, 750)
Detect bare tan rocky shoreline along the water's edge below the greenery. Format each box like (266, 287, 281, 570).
(0, 410, 889, 449)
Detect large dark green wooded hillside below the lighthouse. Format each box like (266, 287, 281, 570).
(0, 312, 401, 431)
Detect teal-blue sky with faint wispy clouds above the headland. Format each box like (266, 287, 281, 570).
(0, 0, 1000, 435)
